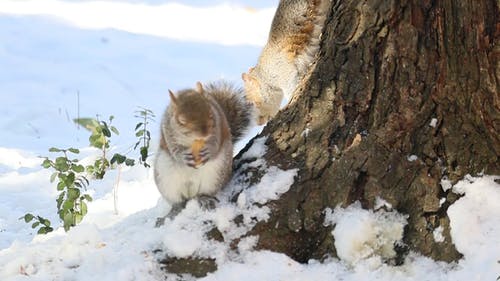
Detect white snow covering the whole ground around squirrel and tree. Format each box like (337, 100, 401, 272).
(0, 0, 500, 281)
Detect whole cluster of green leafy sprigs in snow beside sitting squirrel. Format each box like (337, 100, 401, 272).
(20, 108, 155, 234)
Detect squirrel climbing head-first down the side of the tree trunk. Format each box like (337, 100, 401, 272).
(242, 0, 330, 125)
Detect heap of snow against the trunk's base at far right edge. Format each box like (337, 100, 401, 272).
(448, 176, 500, 280)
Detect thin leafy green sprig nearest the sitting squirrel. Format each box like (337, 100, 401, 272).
(134, 107, 156, 165)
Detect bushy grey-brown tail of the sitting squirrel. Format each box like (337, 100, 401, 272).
(204, 81, 254, 143)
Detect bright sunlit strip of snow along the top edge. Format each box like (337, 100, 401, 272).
(0, 0, 274, 46)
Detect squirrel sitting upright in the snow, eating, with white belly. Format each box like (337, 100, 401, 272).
(154, 82, 254, 209)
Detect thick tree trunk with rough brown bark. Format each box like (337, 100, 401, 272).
(237, 0, 500, 262)
